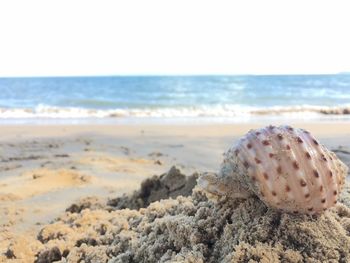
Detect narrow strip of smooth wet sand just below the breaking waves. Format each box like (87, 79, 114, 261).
(0, 119, 350, 138)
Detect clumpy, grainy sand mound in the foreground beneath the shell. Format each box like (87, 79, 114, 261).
(2, 168, 350, 262)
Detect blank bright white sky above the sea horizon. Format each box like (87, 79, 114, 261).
(0, 0, 350, 77)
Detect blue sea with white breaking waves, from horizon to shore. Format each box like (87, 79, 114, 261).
(0, 74, 350, 123)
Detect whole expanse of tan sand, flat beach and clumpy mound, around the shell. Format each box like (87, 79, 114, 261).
(0, 125, 350, 263)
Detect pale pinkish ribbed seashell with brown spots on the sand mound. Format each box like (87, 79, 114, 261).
(198, 126, 348, 214)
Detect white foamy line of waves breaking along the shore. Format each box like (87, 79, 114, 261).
(0, 104, 350, 119)
